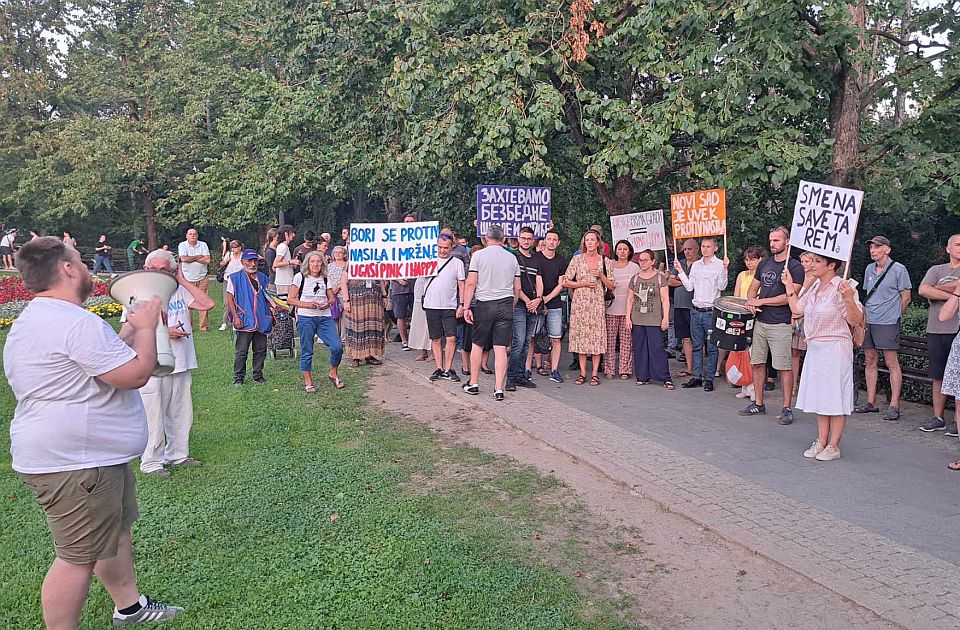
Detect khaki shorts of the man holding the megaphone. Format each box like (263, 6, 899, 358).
(20, 464, 140, 564)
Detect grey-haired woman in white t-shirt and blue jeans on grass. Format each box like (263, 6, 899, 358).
(287, 251, 344, 394)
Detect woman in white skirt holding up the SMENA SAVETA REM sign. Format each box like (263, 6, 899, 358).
(784, 254, 863, 462)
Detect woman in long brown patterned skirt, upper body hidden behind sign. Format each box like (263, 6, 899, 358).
(340, 271, 387, 367)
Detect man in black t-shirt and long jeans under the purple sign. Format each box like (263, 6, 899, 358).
(506, 226, 545, 392)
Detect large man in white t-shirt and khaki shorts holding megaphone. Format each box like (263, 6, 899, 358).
(3, 236, 183, 628)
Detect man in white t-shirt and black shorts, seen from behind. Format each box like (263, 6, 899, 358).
(462, 224, 520, 400)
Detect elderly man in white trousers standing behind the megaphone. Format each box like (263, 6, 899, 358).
(128, 249, 213, 477)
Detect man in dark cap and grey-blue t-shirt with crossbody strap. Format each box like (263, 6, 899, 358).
(853, 236, 913, 420)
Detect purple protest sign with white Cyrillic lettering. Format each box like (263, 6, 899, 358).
(477, 184, 551, 238)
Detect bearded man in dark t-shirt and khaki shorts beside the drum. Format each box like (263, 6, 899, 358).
(740, 225, 804, 425)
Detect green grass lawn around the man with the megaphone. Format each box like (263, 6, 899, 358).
(0, 285, 624, 629)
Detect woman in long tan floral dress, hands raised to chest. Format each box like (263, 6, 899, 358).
(563, 230, 616, 386)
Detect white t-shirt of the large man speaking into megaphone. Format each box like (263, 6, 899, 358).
(3, 297, 147, 474)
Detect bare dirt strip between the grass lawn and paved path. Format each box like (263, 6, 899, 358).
(369, 370, 897, 629)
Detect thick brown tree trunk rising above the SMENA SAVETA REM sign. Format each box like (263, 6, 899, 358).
(827, 0, 867, 186)
